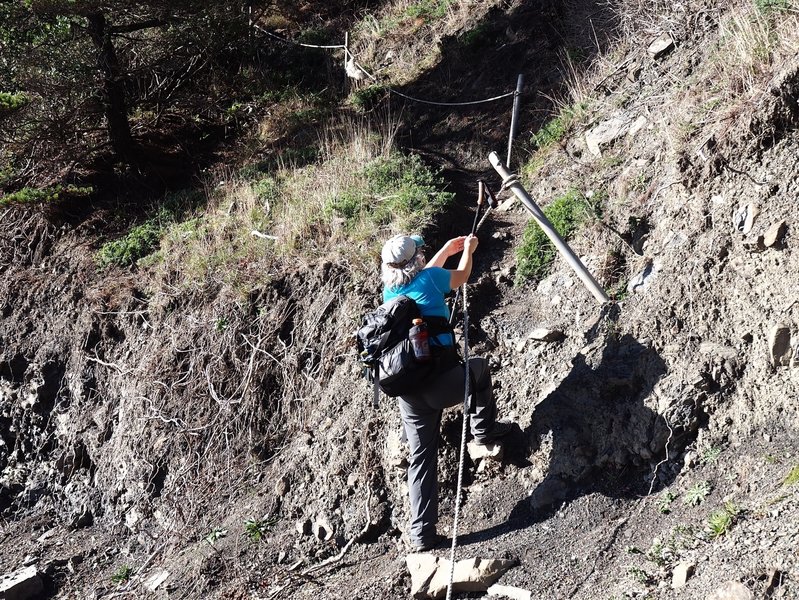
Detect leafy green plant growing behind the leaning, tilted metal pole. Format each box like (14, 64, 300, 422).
(516, 189, 590, 284)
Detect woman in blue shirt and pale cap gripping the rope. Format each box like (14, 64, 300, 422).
(381, 235, 511, 551)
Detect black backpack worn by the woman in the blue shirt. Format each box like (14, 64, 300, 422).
(355, 296, 458, 404)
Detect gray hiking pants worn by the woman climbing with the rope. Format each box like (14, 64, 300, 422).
(399, 358, 497, 545)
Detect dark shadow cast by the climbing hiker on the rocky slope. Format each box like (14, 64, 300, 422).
(461, 326, 690, 544)
